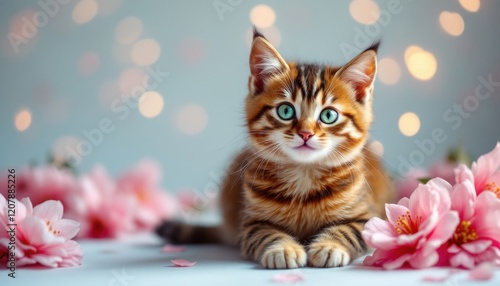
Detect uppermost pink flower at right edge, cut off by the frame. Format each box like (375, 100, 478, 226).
(455, 142, 500, 198)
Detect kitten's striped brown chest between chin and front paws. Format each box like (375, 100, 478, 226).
(248, 165, 358, 240)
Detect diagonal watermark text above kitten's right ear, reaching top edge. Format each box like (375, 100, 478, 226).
(340, 0, 412, 60)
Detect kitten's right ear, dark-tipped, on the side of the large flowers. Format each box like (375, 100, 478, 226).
(336, 42, 380, 103)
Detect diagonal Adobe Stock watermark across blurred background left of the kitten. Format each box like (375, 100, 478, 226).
(65, 65, 170, 166)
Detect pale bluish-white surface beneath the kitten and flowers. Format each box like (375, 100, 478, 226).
(0, 233, 500, 286)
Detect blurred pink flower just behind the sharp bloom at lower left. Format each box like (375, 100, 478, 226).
(68, 167, 134, 238)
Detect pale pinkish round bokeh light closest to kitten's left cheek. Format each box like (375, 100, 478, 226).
(176, 105, 208, 135)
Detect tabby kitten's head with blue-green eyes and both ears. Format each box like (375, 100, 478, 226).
(246, 31, 378, 165)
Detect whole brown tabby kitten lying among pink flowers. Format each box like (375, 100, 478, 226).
(157, 31, 392, 268)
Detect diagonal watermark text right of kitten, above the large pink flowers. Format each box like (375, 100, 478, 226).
(398, 74, 500, 176)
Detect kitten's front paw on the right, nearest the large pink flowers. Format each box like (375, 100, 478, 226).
(307, 243, 351, 267)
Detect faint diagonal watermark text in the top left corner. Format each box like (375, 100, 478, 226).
(7, 0, 72, 54)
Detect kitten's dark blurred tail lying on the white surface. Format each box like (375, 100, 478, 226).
(156, 221, 223, 244)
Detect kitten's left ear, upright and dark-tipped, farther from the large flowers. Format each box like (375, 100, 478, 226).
(250, 28, 289, 94)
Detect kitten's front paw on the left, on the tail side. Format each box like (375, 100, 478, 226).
(260, 243, 307, 269)
